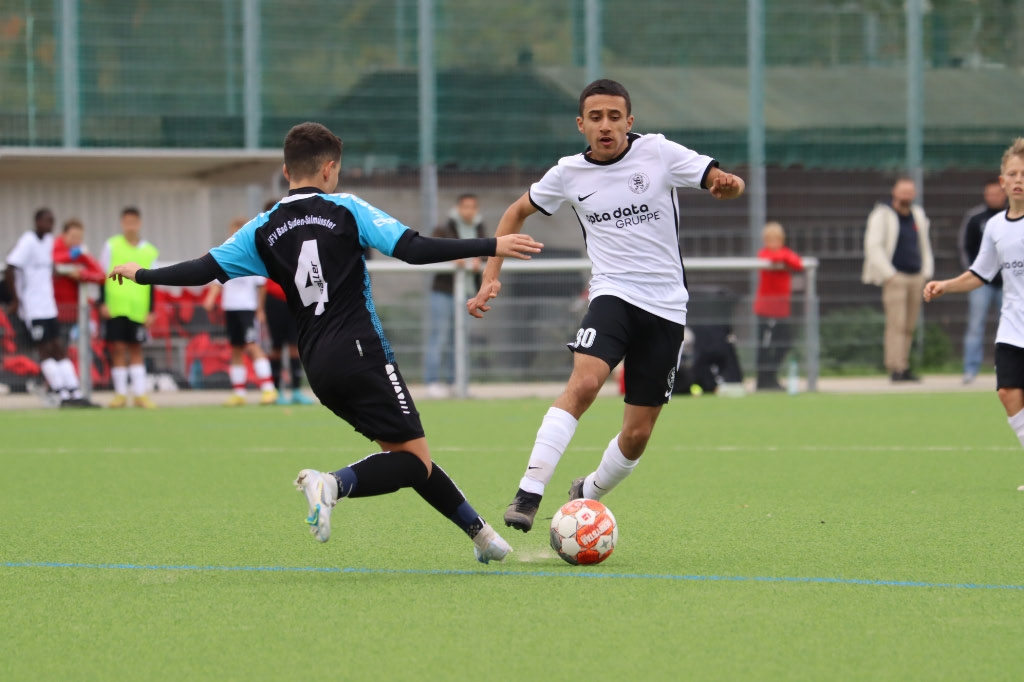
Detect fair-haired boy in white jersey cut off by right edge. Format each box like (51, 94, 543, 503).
(925, 137, 1024, 492)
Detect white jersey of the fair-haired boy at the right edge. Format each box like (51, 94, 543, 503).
(971, 211, 1024, 348)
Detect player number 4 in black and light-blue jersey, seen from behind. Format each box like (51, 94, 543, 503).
(111, 123, 543, 563)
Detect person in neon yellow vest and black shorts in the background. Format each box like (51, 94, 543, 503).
(99, 207, 160, 410)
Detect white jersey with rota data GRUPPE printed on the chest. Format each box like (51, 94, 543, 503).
(529, 133, 717, 325)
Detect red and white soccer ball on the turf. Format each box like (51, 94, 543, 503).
(551, 493, 618, 566)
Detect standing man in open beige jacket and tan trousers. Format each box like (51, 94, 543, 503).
(861, 177, 935, 382)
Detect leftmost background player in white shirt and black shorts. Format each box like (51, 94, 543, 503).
(4, 208, 98, 408)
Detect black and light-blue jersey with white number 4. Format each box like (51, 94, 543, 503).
(210, 188, 409, 374)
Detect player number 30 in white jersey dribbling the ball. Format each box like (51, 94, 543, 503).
(467, 79, 745, 532)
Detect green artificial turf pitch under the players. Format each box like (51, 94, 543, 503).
(0, 393, 1024, 681)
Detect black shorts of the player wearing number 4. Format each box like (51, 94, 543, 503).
(306, 359, 424, 442)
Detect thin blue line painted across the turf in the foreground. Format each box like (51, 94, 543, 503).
(6, 561, 1024, 591)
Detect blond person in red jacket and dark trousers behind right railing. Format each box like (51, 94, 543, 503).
(754, 221, 804, 391)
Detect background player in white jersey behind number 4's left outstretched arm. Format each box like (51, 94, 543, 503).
(203, 218, 278, 408)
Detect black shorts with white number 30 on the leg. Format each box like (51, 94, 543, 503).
(566, 296, 684, 408)
